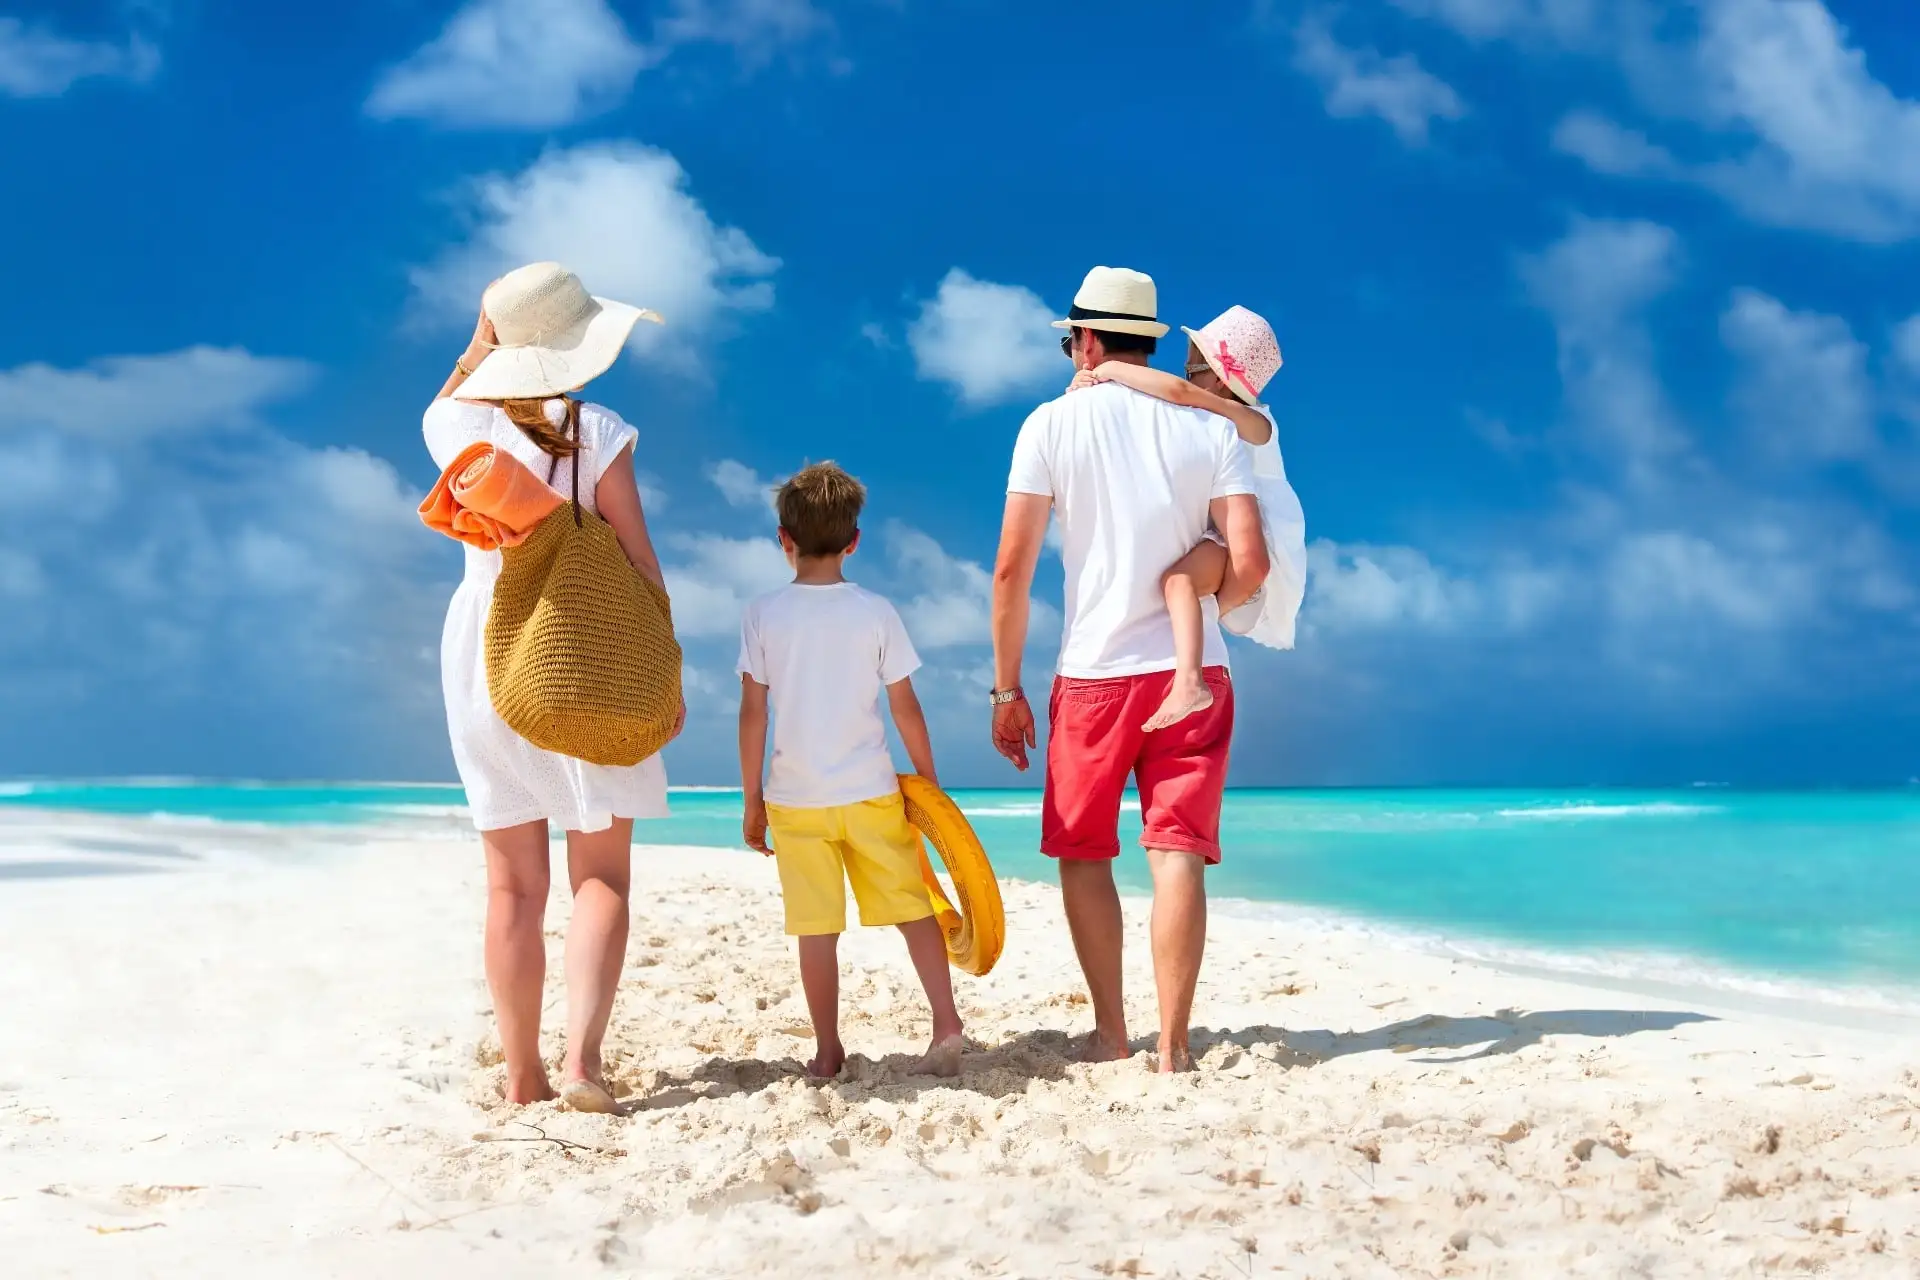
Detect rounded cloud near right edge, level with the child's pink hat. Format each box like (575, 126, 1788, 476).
(1720, 290, 1880, 462)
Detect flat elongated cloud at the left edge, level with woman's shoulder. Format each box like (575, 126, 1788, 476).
(0, 347, 315, 441)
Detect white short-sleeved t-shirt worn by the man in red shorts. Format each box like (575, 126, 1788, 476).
(1006, 382, 1254, 679)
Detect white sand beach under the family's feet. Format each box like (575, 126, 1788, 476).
(0, 814, 1920, 1280)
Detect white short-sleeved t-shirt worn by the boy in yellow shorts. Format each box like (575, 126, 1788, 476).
(739, 581, 920, 808)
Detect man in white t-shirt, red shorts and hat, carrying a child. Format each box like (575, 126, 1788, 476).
(993, 267, 1267, 1071)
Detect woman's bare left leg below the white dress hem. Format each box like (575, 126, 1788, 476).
(480, 821, 553, 1103)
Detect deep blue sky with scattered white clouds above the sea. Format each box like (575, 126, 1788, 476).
(0, 0, 1920, 785)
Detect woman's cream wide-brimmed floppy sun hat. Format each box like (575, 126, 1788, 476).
(455, 263, 664, 408)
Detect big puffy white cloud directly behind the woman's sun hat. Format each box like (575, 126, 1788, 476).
(411, 142, 780, 365)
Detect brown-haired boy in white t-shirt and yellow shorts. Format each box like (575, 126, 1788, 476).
(739, 462, 960, 1079)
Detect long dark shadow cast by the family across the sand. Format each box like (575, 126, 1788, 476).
(622, 1009, 1715, 1113)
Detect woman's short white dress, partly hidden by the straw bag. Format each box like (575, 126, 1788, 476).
(424, 397, 666, 831)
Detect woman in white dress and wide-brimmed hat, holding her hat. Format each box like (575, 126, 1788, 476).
(424, 263, 685, 1111)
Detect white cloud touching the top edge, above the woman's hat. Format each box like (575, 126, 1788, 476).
(367, 0, 649, 129)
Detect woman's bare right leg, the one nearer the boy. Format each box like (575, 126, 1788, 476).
(561, 818, 634, 1111)
